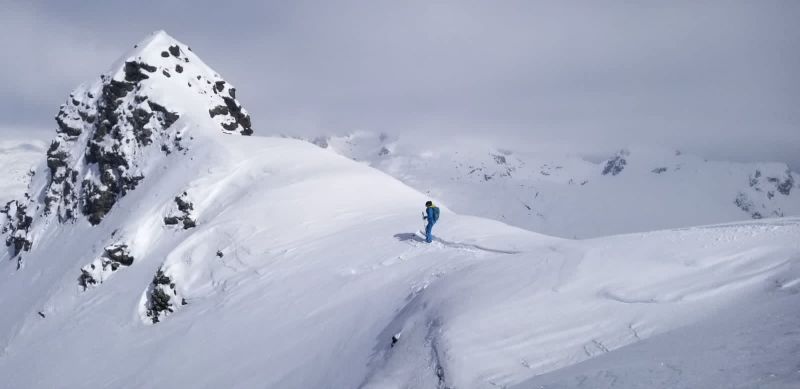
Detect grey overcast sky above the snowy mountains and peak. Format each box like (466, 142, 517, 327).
(0, 0, 800, 170)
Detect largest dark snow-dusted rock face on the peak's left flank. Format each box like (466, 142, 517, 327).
(45, 61, 179, 224)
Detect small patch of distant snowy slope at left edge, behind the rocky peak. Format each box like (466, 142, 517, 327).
(0, 137, 47, 205)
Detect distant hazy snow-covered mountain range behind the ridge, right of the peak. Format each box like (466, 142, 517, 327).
(312, 132, 800, 238)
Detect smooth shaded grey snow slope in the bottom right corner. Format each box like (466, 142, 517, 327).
(513, 284, 800, 389)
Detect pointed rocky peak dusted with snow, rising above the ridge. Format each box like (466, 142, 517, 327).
(2, 31, 253, 256)
